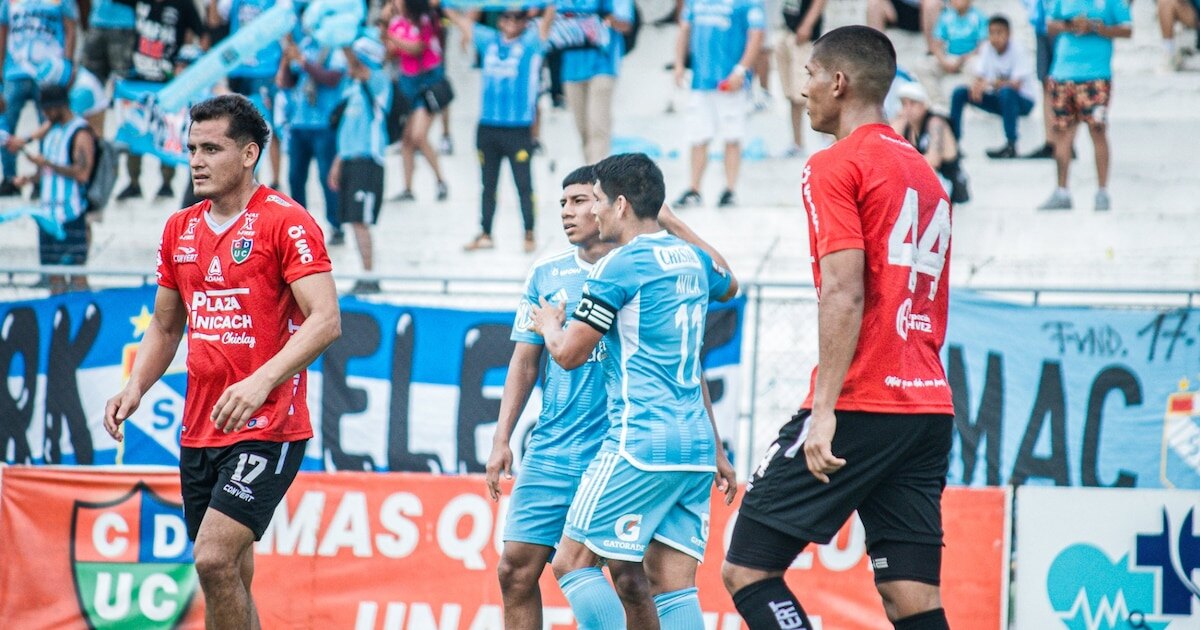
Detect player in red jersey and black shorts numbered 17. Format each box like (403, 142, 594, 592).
(104, 95, 341, 629)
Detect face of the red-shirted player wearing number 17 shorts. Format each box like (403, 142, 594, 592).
(187, 118, 258, 199)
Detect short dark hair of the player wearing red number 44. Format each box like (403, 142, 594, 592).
(812, 25, 896, 103)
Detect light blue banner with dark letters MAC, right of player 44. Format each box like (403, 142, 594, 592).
(943, 290, 1200, 488)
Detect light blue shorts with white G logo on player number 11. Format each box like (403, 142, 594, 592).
(566, 451, 713, 562)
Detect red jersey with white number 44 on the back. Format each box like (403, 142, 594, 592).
(800, 125, 954, 414)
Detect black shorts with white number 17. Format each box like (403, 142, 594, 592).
(179, 439, 308, 540)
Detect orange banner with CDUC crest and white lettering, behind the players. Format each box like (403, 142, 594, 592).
(0, 467, 1008, 630)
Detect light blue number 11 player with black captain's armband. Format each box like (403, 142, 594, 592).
(533, 154, 737, 630)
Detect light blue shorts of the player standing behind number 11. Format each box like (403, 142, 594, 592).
(504, 460, 580, 547)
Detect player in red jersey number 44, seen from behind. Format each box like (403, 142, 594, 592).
(721, 26, 954, 630)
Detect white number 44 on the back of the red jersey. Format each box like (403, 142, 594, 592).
(888, 188, 950, 300)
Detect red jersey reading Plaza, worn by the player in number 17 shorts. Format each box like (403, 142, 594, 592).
(158, 186, 331, 448)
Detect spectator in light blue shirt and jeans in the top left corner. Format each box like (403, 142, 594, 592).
(0, 0, 79, 197)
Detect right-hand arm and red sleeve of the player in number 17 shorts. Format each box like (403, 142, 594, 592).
(209, 213, 342, 433)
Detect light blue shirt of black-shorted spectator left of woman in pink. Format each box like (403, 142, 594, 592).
(337, 66, 392, 166)
